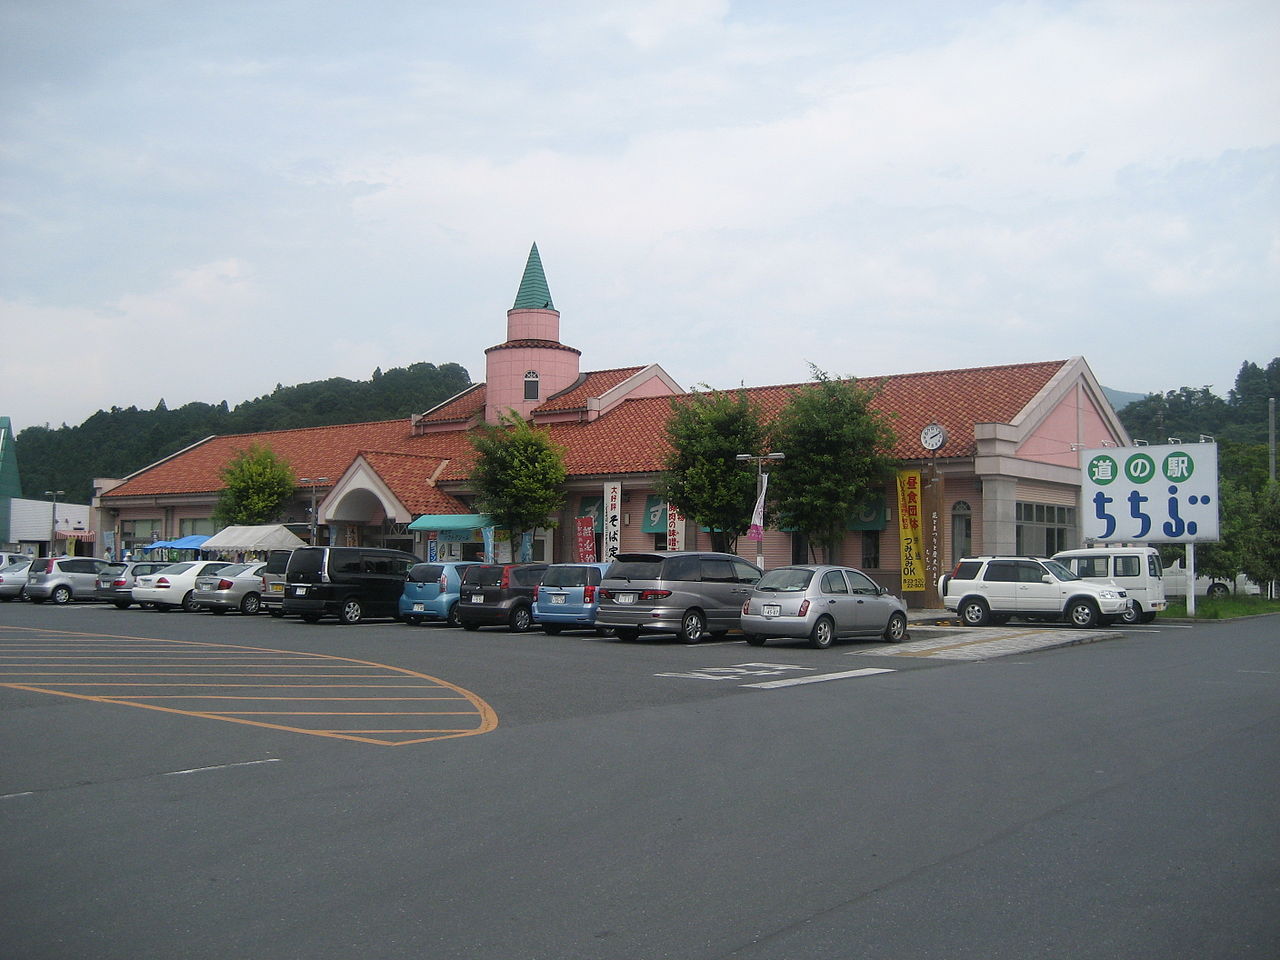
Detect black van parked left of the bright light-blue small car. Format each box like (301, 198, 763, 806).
(284, 547, 420, 623)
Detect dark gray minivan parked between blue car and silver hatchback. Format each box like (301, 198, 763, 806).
(595, 550, 762, 644)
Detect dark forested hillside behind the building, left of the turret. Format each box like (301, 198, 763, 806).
(14, 364, 471, 503)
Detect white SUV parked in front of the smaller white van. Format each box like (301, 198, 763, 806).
(938, 557, 1129, 627)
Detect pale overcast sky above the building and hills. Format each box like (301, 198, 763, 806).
(0, 0, 1280, 430)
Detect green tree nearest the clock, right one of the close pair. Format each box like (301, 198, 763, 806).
(769, 366, 897, 559)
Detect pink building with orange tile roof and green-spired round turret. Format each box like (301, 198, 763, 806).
(95, 244, 1128, 605)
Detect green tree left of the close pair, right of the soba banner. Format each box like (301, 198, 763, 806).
(658, 390, 764, 553)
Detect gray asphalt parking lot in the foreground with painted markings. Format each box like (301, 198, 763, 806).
(0, 604, 1280, 960)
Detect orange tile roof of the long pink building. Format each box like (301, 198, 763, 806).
(104, 360, 1066, 513)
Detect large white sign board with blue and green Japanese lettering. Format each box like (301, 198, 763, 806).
(1080, 443, 1219, 543)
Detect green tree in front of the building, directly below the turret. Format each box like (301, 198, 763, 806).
(470, 411, 567, 552)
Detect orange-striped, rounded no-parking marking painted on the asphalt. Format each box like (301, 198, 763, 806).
(0, 627, 498, 746)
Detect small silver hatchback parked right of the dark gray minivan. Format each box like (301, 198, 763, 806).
(741, 564, 906, 650)
